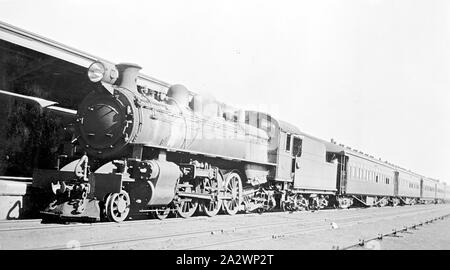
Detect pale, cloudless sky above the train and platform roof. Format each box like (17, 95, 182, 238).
(0, 0, 450, 183)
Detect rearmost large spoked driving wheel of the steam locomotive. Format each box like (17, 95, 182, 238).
(223, 172, 242, 215)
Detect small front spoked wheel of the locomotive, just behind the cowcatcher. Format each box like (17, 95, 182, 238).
(105, 190, 130, 222)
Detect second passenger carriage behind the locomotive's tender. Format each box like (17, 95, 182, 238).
(394, 167, 422, 205)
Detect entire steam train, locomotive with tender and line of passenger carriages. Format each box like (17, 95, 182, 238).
(14, 62, 446, 222)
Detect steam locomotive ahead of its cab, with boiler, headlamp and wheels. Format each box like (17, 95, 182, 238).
(33, 62, 274, 221)
